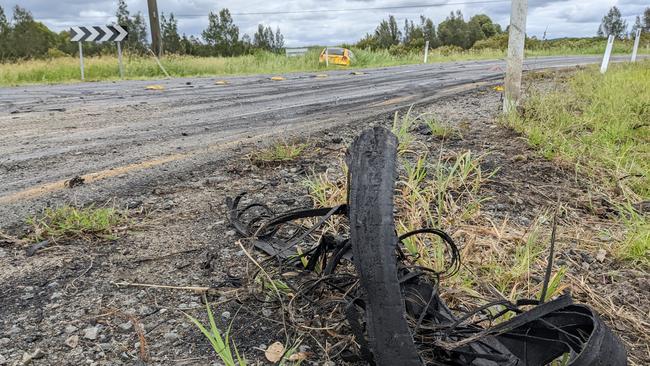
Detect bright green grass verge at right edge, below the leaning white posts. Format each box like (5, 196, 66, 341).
(504, 61, 650, 265)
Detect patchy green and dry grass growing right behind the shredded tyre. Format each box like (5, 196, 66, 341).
(304, 110, 566, 308)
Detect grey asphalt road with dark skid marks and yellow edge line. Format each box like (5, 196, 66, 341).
(0, 57, 627, 229)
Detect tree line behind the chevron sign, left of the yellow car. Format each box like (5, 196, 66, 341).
(0, 0, 284, 61)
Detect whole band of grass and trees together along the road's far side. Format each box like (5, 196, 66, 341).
(0, 0, 650, 86)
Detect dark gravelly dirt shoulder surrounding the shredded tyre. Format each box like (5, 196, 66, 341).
(0, 81, 650, 365)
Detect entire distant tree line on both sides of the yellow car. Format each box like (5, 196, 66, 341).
(0, 0, 650, 61)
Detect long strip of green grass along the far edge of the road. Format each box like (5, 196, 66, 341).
(0, 44, 645, 86)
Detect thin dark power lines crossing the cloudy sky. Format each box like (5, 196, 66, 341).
(33, 0, 510, 19)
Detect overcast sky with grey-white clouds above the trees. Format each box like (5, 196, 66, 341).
(0, 0, 650, 46)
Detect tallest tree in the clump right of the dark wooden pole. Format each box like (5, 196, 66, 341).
(201, 9, 240, 56)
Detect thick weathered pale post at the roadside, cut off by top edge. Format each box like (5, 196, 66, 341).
(503, 0, 528, 113)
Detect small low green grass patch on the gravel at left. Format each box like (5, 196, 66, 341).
(27, 205, 128, 242)
